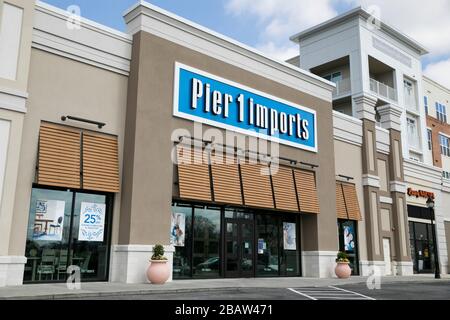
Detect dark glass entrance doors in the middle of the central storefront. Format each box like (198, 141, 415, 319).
(225, 211, 255, 278)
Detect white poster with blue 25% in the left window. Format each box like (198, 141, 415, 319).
(78, 202, 106, 242)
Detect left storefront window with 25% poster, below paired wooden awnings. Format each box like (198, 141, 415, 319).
(24, 188, 111, 282)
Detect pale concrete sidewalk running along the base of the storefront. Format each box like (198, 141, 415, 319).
(0, 275, 450, 300)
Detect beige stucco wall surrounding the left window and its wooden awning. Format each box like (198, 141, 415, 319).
(9, 49, 127, 255)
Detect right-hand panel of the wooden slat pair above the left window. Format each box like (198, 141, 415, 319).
(83, 132, 120, 192)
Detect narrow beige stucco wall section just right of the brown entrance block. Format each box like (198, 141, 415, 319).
(334, 140, 367, 260)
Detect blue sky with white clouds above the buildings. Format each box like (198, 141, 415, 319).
(44, 0, 450, 87)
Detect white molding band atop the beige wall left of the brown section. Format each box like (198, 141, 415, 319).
(32, 1, 133, 76)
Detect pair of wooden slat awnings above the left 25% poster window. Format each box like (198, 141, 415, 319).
(37, 122, 120, 192)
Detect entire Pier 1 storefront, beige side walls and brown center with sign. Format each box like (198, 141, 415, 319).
(0, 3, 384, 285)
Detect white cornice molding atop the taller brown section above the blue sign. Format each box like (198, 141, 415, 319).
(124, 1, 336, 102)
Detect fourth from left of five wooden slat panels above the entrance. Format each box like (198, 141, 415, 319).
(271, 166, 299, 212)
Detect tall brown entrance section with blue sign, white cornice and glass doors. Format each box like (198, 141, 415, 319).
(112, 1, 338, 281)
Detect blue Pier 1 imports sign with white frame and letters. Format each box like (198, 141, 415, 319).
(173, 63, 318, 152)
